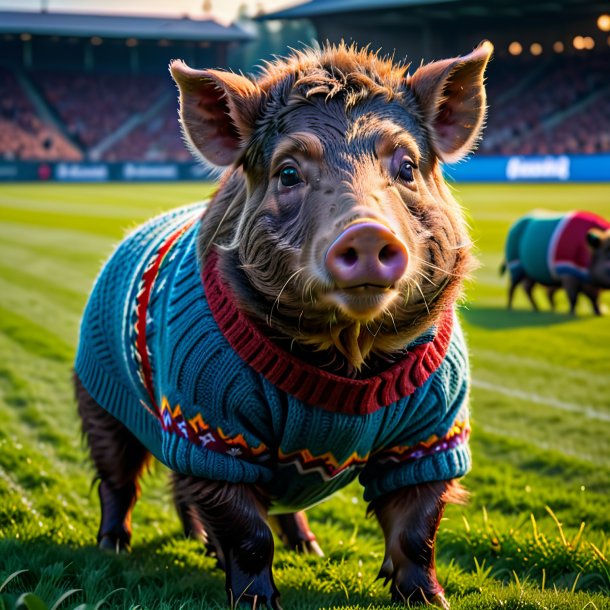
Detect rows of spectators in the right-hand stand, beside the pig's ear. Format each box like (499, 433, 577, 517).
(480, 52, 610, 155)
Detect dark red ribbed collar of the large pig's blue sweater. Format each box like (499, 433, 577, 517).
(202, 250, 453, 415)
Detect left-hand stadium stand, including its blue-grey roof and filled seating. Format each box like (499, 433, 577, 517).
(0, 11, 252, 161)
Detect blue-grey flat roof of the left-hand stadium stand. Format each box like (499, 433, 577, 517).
(0, 11, 253, 42)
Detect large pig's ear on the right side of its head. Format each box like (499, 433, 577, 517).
(408, 41, 493, 163)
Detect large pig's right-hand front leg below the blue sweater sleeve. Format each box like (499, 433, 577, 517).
(369, 481, 461, 608)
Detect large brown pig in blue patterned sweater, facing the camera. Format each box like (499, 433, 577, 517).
(75, 43, 491, 608)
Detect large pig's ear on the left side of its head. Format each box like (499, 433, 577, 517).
(170, 60, 261, 166)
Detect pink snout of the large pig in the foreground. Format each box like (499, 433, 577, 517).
(325, 221, 409, 288)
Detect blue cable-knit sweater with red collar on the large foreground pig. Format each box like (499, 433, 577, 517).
(75, 204, 470, 512)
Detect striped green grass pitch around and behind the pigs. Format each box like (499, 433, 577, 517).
(0, 184, 610, 610)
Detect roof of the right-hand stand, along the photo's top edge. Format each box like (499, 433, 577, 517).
(258, 0, 608, 19)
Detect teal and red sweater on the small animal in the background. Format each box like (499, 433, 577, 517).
(506, 212, 610, 285)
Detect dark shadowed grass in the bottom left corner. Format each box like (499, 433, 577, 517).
(0, 537, 226, 610)
